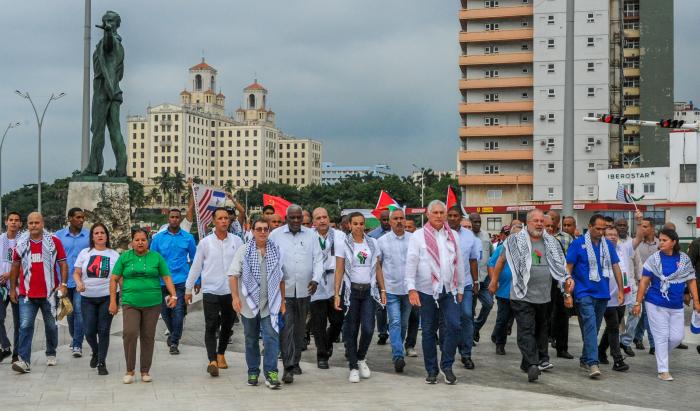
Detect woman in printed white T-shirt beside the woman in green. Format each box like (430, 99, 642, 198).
(73, 223, 119, 375)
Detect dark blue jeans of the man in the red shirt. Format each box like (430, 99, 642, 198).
(18, 296, 58, 364)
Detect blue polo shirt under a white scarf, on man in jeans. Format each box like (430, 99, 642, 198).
(566, 236, 620, 301)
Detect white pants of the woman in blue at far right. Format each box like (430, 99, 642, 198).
(644, 302, 685, 373)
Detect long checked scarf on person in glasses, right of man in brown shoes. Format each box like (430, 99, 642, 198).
(241, 240, 283, 332)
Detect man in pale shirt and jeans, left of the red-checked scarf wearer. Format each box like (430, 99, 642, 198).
(377, 210, 413, 372)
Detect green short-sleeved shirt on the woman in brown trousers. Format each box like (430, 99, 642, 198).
(112, 250, 170, 308)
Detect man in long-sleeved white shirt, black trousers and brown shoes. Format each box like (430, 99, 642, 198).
(185, 207, 243, 377)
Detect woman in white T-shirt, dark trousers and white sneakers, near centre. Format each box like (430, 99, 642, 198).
(335, 212, 386, 383)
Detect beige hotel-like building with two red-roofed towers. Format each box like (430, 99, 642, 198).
(127, 59, 322, 194)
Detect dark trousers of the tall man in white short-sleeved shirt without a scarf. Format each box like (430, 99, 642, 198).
(280, 297, 311, 369)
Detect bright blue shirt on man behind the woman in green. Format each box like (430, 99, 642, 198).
(151, 229, 197, 284)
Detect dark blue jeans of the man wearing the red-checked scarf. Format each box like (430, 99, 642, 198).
(418, 289, 461, 375)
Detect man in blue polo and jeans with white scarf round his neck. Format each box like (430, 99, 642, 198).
(565, 214, 625, 378)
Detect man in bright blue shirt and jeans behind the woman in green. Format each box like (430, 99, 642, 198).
(151, 208, 198, 355)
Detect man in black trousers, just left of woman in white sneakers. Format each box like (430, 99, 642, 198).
(310, 207, 345, 370)
